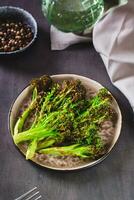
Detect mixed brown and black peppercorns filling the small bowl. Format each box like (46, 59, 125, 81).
(0, 20, 33, 52)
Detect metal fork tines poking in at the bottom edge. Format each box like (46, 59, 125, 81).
(14, 187, 42, 200)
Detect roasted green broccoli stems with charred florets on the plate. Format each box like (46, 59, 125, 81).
(13, 76, 115, 159)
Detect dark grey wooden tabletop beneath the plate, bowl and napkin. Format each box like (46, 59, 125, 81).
(0, 0, 134, 200)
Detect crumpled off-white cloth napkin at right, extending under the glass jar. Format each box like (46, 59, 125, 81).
(51, 0, 134, 110)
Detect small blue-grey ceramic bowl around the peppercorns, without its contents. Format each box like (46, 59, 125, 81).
(0, 6, 37, 55)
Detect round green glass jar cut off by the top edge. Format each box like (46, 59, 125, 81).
(42, 0, 104, 32)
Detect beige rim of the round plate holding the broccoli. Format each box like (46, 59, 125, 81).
(8, 74, 122, 171)
